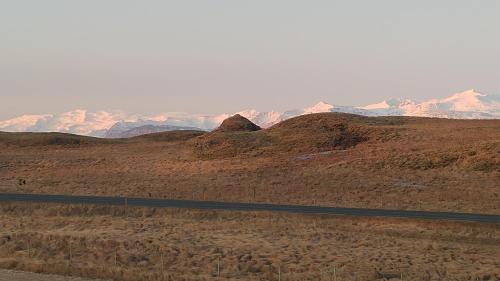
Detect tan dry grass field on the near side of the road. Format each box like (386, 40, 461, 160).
(0, 203, 500, 281)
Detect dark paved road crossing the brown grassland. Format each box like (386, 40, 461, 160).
(0, 193, 500, 223)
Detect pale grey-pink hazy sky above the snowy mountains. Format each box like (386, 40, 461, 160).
(0, 0, 500, 119)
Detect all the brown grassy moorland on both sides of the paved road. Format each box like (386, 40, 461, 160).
(0, 113, 500, 281)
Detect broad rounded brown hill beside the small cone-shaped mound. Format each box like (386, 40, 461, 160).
(193, 113, 372, 158)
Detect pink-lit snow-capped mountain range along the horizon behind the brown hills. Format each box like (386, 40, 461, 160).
(0, 90, 500, 137)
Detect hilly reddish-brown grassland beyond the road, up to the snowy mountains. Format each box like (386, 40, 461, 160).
(0, 113, 500, 213)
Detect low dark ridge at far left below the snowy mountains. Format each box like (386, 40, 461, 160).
(0, 132, 112, 147)
